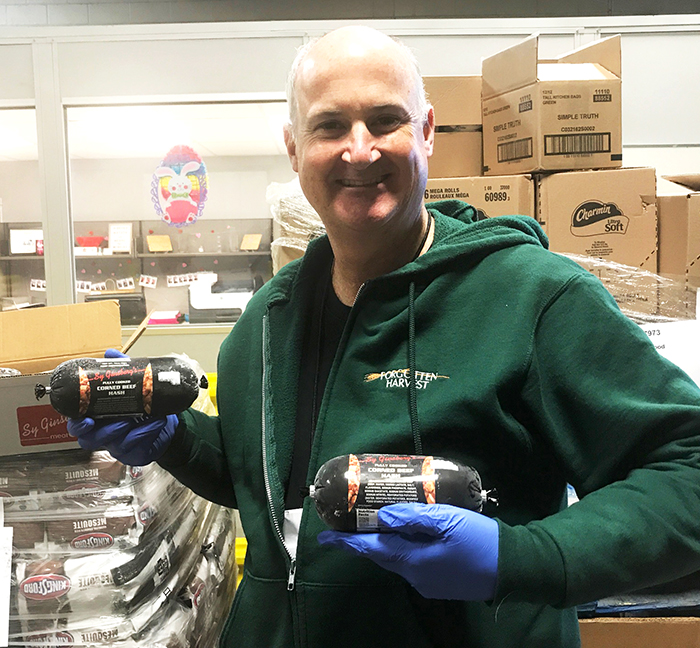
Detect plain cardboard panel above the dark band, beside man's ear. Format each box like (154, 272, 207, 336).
(423, 74, 481, 126)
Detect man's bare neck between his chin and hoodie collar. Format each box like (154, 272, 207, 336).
(331, 207, 434, 306)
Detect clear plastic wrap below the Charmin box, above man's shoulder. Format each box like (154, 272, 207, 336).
(562, 254, 697, 324)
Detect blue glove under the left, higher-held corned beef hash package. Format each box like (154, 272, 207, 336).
(67, 349, 178, 466)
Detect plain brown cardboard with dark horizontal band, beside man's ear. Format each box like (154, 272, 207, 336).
(423, 75, 483, 178)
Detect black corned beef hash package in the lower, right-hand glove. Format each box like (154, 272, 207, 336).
(309, 454, 494, 532)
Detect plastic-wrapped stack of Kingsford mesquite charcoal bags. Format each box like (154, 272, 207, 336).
(0, 450, 237, 648)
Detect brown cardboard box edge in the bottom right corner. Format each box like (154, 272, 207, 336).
(579, 617, 700, 648)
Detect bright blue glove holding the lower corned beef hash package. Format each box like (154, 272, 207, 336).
(318, 503, 498, 601)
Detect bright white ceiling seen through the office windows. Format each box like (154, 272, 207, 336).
(0, 101, 287, 161)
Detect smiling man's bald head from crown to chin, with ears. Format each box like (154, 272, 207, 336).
(285, 28, 434, 239)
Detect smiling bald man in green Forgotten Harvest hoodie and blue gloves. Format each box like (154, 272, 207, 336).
(70, 27, 700, 648)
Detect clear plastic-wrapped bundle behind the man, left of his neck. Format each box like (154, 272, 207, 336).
(266, 178, 326, 273)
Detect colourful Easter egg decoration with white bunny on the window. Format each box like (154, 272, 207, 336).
(151, 145, 208, 227)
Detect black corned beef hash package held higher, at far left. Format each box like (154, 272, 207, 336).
(34, 356, 207, 418)
